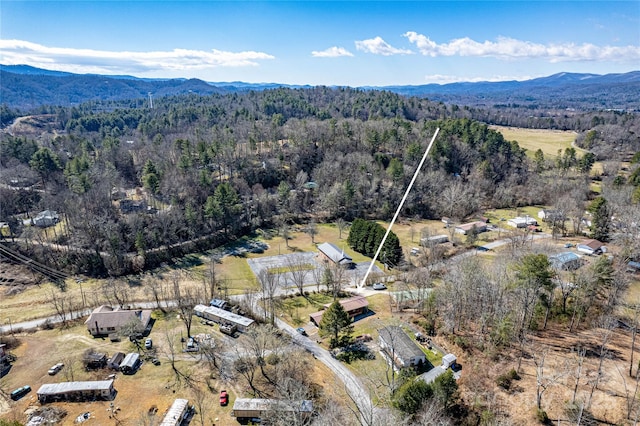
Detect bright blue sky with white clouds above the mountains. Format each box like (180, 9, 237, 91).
(0, 0, 640, 86)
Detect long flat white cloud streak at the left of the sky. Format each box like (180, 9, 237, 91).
(0, 40, 274, 74)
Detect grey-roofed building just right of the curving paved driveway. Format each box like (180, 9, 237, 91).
(378, 325, 427, 369)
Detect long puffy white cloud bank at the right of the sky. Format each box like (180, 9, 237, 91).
(404, 31, 640, 62)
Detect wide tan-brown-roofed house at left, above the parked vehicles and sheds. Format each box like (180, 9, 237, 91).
(84, 305, 151, 337)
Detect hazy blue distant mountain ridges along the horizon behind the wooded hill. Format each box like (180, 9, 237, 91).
(0, 65, 640, 111)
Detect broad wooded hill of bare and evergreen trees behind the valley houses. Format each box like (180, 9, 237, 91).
(0, 85, 640, 275)
